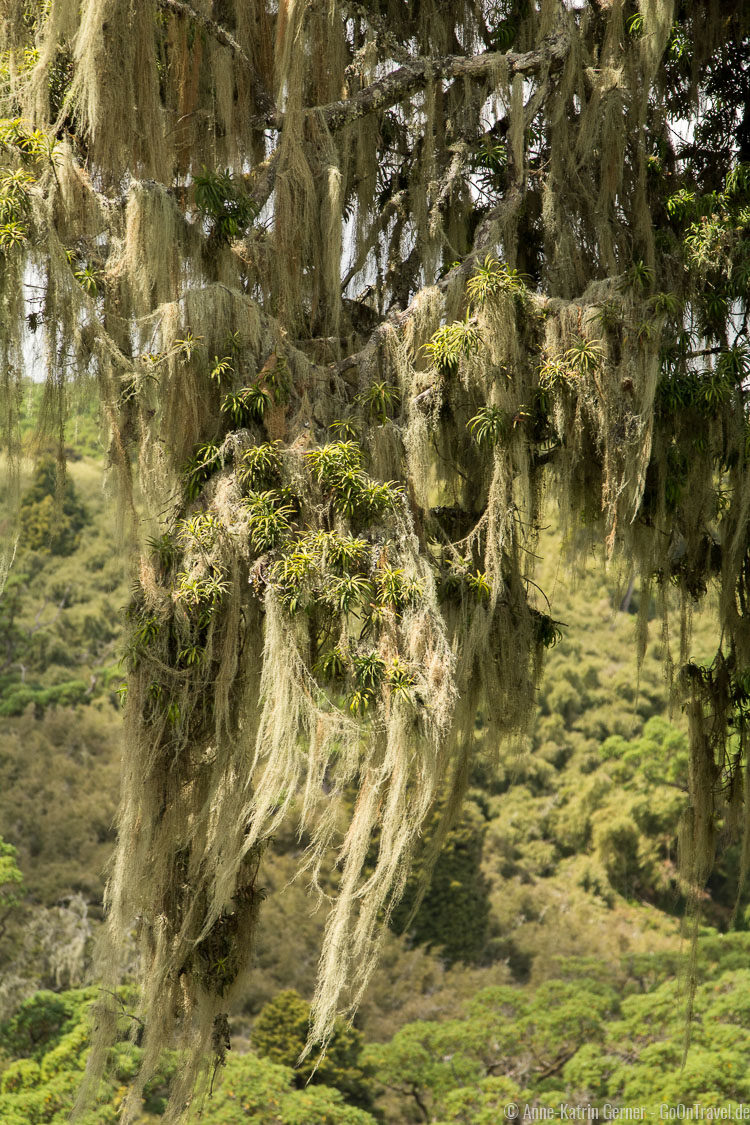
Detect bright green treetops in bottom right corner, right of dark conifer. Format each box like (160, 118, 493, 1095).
(367, 934, 748, 1125)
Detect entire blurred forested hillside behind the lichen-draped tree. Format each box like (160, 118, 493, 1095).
(0, 398, 750, 1125)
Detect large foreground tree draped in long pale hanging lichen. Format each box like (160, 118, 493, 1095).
(0, 0, 750, 1116)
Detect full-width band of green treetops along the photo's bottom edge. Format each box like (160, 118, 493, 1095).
(7, 934, 750, 1125)
